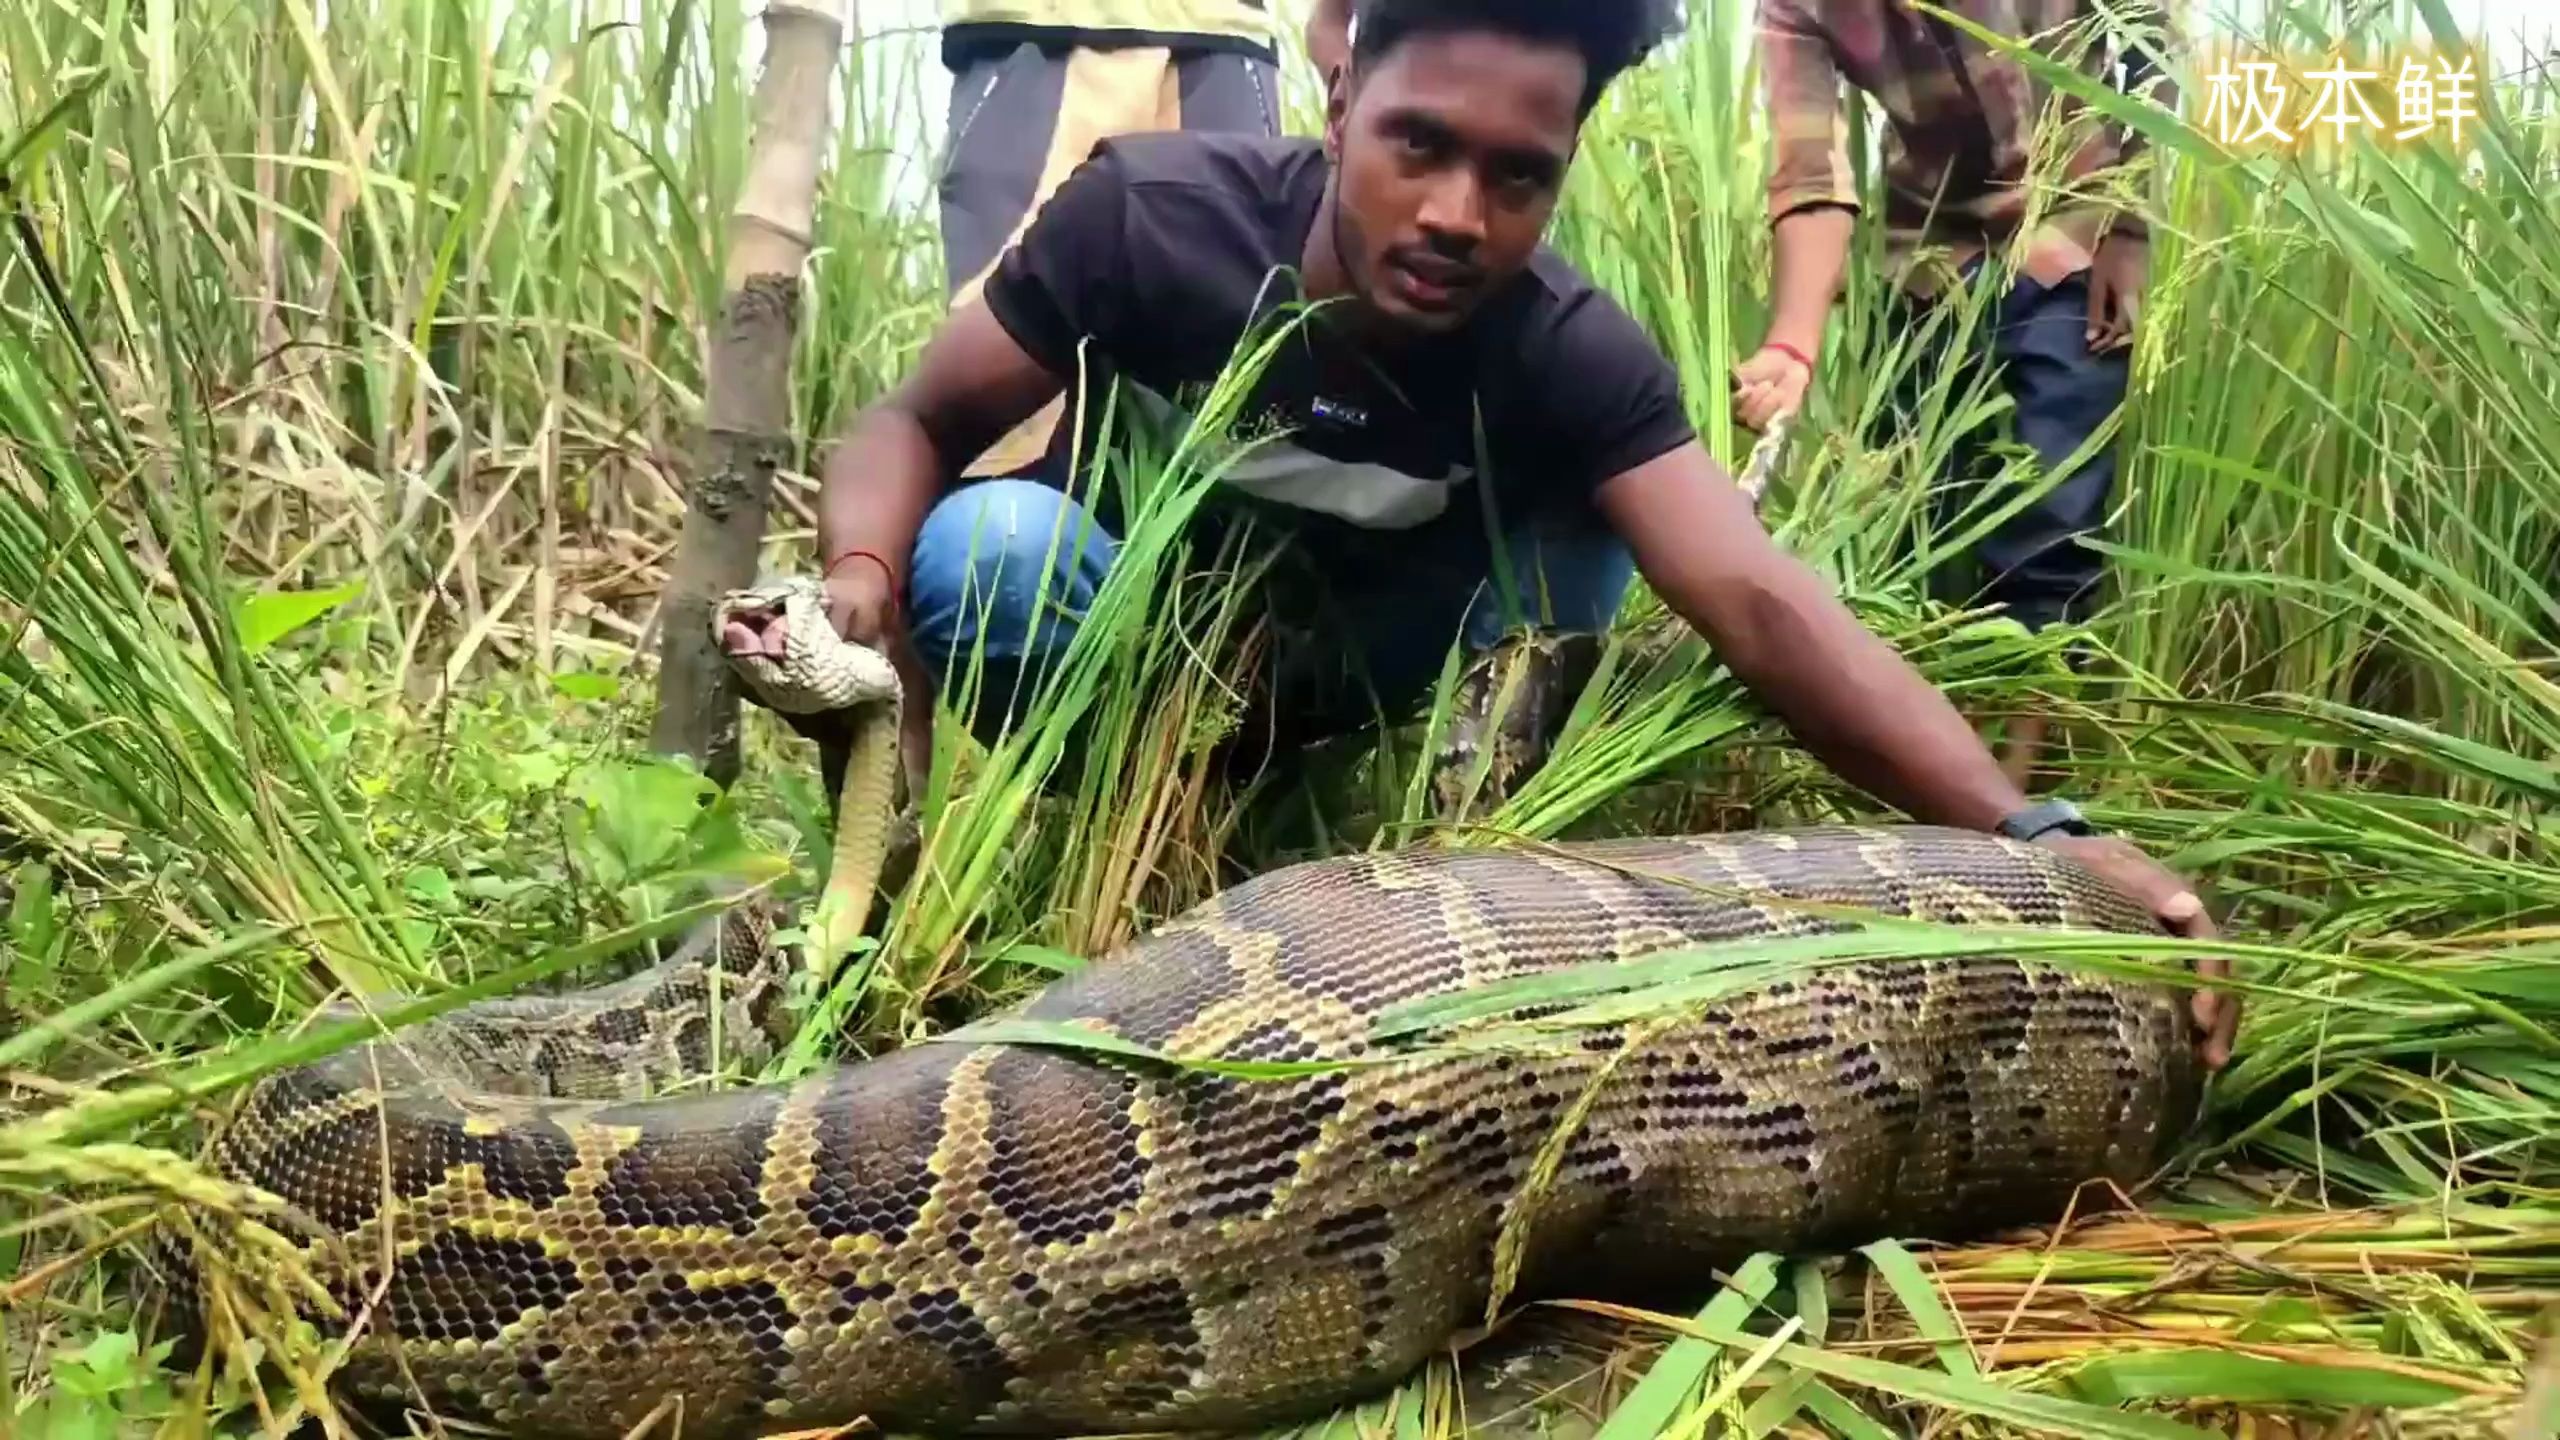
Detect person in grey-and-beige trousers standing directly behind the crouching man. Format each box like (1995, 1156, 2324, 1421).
(940, 0, 1300, 474)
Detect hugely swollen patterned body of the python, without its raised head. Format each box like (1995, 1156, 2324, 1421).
(160, 828, 2196, 1437)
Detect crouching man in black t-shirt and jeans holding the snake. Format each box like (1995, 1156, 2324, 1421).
(819, 0, 2237, 1063)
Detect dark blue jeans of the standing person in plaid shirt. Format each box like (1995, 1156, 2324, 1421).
(1905, 266, 2130, 630)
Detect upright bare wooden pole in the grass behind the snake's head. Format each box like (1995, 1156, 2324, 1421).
(650, 0, 845, 784)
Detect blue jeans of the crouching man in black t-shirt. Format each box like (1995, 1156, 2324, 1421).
(909, 479, 1636, 740)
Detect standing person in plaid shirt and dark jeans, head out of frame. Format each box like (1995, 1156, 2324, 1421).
(1733, 0, 2173, 787)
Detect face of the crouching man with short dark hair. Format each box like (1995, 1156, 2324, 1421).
(1326, 31, 1582, 331)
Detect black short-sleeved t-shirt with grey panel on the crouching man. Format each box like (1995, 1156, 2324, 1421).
(986, 133, 1695, 556)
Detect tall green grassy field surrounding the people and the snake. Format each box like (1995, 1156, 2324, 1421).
(0, 0, 2560, 1440)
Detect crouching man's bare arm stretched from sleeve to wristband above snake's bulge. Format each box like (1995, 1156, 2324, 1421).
(1600, 441, 2028, 830)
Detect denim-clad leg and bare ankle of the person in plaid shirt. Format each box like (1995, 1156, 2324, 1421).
(1976, 272, 2132, 789)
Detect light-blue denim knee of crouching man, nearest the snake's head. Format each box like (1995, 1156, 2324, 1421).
(909, 479, 1119, 674)
